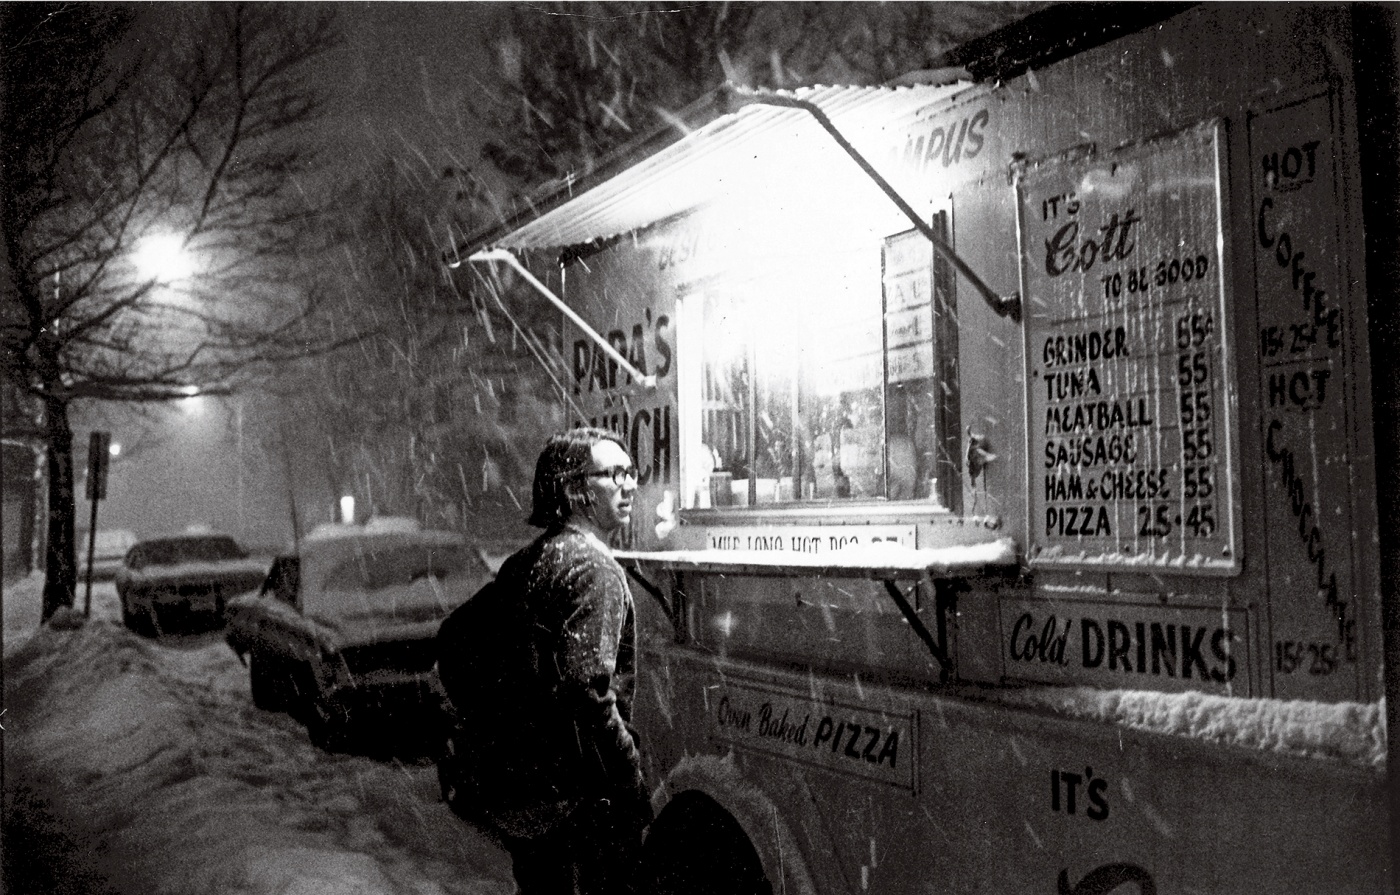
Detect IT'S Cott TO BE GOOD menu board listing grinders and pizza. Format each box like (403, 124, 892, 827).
(1016, 123, 1239, 571)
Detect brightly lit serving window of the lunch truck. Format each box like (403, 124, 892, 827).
(685, 214, 958, 508)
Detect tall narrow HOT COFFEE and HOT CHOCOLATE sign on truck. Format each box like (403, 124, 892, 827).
(1249, 94, 1365, 699)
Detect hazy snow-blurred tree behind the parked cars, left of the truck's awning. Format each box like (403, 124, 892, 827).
(264, 160, 559, 541)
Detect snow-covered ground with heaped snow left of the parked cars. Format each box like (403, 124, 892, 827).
(3, 581, 514, 895)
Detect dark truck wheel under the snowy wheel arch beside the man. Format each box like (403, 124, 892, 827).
(637, 791, 773, 895)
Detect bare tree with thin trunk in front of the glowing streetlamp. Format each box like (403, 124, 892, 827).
(0, 4, 337, 619)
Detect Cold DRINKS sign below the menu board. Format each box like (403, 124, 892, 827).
(1001, 594, 1253, 696)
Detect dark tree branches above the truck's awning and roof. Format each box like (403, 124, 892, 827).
(464, 1, 1043, 191)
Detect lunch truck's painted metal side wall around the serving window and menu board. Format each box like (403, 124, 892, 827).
(532, 4, 1390, 895)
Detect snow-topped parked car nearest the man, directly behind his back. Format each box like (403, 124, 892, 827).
(225, 525, 491, 749)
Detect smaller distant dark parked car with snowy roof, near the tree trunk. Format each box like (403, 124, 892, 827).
(116, 534, 267, 633)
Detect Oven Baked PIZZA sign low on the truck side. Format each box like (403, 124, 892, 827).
(706, 679, 918, 791)
